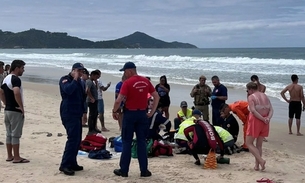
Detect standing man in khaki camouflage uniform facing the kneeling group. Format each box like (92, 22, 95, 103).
(190, 75, 212, 121)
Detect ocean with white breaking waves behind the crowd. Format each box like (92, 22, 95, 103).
(0, 48, 305, 101)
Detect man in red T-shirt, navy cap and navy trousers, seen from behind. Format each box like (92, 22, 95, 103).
(112, 62, 160, 177)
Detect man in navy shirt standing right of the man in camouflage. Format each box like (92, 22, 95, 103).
(211, 76, 228, 126)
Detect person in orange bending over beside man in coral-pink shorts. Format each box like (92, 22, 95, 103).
(229, 100, 249, 151)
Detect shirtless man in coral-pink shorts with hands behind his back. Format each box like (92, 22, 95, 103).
(246, 82, 273, 171)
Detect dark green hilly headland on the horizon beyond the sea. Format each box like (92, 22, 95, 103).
(0, 29, 197, 48)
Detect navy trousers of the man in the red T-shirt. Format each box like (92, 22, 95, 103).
(120, 110, 149, 173)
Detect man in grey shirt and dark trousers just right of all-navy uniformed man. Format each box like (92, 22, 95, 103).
(86, 70, 101, 134)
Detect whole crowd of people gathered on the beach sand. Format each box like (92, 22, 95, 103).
(0, 60, 305, 177)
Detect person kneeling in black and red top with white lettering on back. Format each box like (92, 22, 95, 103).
(184, 111, 224, 165)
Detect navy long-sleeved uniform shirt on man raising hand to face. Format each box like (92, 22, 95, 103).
(59, 74, 85, 118)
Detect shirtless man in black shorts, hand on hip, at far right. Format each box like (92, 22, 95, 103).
(281, 74, 305, 136)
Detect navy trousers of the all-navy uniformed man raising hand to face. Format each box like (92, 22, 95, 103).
(60, 116, 82, 168)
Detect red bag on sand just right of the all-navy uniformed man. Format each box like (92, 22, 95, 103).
(80, 133, 107, 152)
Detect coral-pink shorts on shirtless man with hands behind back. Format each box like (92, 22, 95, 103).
(246, 113, 269, 138)
